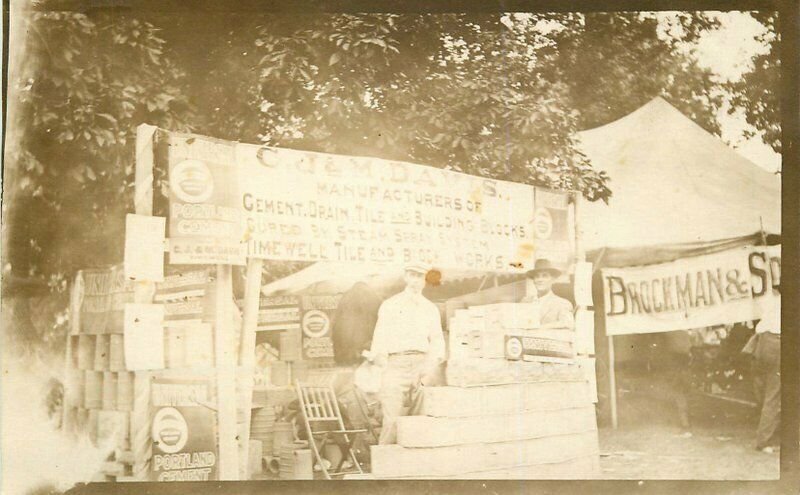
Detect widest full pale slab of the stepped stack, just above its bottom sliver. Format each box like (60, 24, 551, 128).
(371, 431, 600, 477)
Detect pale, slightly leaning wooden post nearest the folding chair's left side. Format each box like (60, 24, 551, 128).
(239, 258, 264, 479)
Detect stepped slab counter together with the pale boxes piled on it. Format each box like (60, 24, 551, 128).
(371, 303, 600, 479)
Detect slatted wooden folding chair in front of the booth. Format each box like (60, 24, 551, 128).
(296, 381, 367, 480)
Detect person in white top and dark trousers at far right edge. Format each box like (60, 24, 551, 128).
(753, 290, 781, 453)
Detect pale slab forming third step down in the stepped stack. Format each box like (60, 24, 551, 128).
(397, 407, 597, 447)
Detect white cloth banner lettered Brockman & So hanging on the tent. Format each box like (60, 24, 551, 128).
(601, 246, 781, 335)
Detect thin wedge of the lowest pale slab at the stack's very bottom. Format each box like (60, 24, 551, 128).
(378, 455, 600, 480)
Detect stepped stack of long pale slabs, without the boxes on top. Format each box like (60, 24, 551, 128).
(372, 372, 600, 479)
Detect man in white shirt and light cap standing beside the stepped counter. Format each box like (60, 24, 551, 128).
(371, 263, 445, 445)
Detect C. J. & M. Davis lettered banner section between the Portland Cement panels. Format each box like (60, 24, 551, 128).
(236, 144, 568, 271)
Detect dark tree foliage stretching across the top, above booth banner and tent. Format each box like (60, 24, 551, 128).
(4, 11, 748, 292)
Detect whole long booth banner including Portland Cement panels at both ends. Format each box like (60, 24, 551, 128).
(158, 134, 573, 272)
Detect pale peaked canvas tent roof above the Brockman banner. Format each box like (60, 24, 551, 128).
(579, 97, 781, 261)
